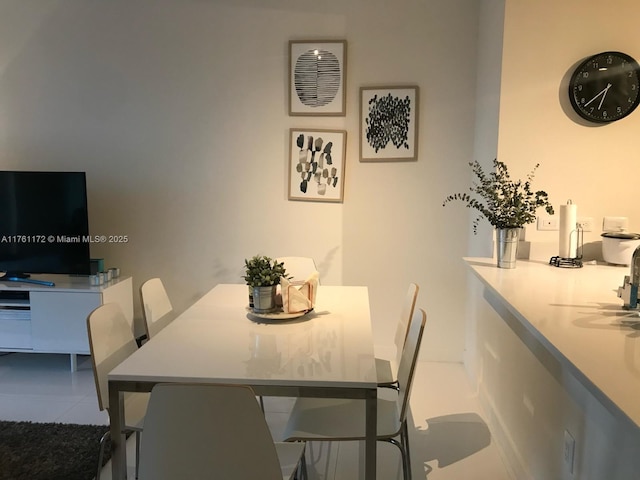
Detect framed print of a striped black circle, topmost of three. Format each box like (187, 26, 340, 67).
(289, 40, 347, 117)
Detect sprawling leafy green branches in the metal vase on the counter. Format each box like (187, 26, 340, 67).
(442, 159, 554, 234)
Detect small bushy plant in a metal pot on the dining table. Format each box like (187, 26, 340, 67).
(243, 255, 286, 313)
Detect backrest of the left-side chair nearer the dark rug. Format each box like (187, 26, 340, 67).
(87, 303, 138, 410)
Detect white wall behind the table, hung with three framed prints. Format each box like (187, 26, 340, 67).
(0, 0, 477, 360)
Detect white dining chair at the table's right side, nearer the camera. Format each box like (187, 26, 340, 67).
(283, 309, 427, 480)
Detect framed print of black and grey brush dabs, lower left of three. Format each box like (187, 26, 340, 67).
(288, 128, 347, 203)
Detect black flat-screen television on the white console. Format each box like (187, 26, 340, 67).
(0, 171, 91, 284)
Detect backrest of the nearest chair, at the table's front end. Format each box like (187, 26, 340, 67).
(138, 383, 282, 480)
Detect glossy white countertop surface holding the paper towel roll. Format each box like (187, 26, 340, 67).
(465, 258, 640, 427)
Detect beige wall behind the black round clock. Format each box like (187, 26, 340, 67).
(498, 0, 640, 260)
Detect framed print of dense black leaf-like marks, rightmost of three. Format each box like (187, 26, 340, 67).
(360, 85, 420, 162)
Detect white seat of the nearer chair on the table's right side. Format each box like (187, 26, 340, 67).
(284, 395, 401, 441)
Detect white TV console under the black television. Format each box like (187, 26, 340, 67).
(0, 275, 133, 371)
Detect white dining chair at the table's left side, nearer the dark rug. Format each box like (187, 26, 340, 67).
(87, 303, 149, 480)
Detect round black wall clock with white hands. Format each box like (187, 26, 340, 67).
(569, 52, 640, 123)
